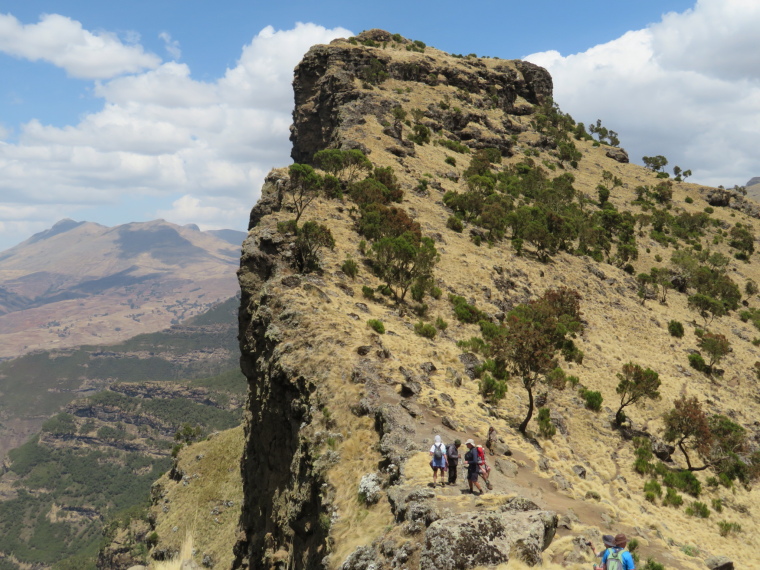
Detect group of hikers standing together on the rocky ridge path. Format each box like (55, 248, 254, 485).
(430, 428, 496, 495)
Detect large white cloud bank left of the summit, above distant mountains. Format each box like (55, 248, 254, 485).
(0, 21, 352, 249)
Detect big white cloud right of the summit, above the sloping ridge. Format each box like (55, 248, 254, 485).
(526, 0, 760, 186)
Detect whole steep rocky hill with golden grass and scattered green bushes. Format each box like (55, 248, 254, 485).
(234, 30, 760, 570)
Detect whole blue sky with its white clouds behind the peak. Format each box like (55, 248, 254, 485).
(0, 0, 760, 250)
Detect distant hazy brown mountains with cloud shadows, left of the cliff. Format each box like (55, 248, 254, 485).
(0, 219, 245, 358)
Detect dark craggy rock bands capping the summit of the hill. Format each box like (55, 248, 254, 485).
(290, 36, 553, 163)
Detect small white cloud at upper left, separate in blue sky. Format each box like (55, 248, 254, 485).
(0, 14, 161, 79)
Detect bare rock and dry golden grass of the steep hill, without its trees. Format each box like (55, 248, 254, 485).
(234, 30, 760, 570)
